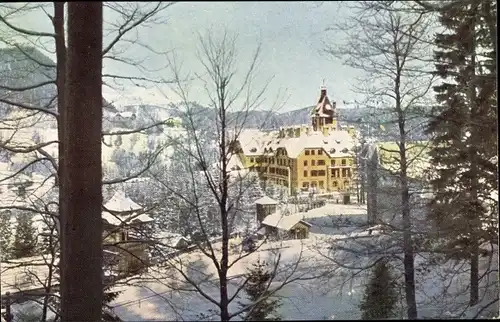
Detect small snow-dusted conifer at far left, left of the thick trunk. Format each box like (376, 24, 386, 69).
(12, 213, 37, 258)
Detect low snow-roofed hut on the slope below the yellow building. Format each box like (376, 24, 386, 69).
(262, 211, 311, 239)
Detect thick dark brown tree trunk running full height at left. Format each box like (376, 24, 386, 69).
(61, 2, 103, 322)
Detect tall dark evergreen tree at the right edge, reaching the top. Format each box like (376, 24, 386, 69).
(427, 0, 498, 305)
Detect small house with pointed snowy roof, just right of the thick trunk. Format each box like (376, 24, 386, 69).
(102, 191, 153, 275)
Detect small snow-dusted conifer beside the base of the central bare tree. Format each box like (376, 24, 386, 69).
(239, 259, 281, 321)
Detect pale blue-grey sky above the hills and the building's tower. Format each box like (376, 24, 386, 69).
(5, 1, 362, 111)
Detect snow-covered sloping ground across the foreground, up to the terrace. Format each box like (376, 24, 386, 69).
(5, 205, 498, 321)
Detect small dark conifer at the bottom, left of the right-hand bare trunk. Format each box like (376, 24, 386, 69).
(359, 261, 398, 320)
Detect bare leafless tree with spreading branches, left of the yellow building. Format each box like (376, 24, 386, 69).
(125, 31, 330, 321)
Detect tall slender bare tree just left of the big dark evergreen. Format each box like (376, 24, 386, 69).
(325, 1, 432, 319)
